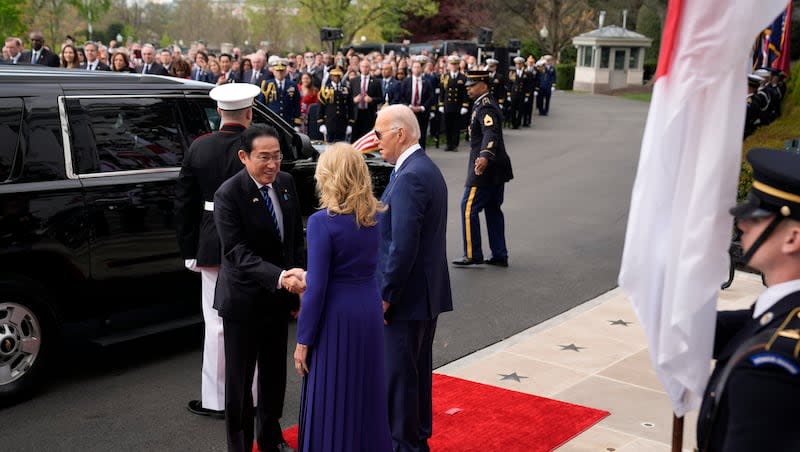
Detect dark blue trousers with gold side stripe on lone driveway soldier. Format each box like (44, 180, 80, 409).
(461, 184, 508, 260)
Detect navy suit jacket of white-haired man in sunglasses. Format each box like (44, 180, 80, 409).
(377, 149, 453, 321)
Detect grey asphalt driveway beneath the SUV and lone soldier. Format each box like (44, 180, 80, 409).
(0, 92, 647, 452)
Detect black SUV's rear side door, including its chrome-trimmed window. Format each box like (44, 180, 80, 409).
(60, 95, 200, 333)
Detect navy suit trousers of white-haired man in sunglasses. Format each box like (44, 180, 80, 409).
(383, 318, 437, 452)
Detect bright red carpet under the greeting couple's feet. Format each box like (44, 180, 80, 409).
(268, 374, 609, 452)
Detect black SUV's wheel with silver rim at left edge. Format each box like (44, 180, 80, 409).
(0, 275, 59, 406)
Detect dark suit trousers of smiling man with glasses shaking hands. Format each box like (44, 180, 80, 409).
(222, 312, 289, 452)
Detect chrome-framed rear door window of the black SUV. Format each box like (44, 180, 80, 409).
(66, 97, 184, 174)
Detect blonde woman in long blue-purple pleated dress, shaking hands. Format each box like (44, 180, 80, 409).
(294, 143, 392, 452)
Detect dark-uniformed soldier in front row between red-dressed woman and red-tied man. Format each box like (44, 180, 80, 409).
(317, 66, 353, 143)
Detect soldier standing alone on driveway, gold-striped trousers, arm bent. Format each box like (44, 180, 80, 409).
(453, 71, 514, 267)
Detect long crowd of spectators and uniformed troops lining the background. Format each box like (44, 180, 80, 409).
(0, 32, 556, 151)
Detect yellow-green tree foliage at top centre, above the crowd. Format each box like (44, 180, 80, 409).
(298, 0, 438, 42)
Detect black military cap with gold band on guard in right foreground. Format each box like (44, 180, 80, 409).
(730, 148, 800, 220)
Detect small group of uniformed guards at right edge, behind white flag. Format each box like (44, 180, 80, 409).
(744, 68, 786, 138)
